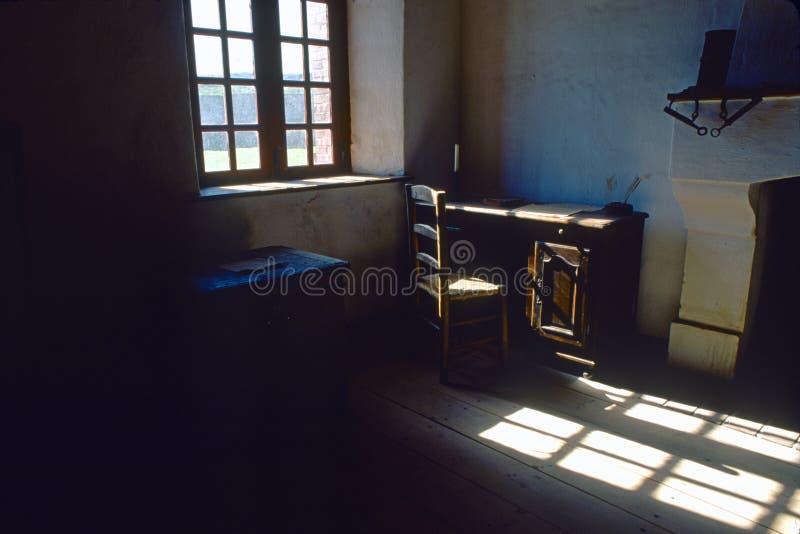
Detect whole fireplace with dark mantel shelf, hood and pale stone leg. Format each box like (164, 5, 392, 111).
(666, 0, 800, 378)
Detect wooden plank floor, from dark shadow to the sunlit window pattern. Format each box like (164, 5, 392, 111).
(344, 344, 800, 534)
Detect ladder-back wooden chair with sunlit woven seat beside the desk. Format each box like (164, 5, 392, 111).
(406, 184, 508, 383)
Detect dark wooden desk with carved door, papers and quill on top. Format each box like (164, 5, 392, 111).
(447, 202, 648, 365)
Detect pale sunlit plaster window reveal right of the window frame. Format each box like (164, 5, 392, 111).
(347, 0, 404, 175)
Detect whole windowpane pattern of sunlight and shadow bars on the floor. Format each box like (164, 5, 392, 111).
(466, 379, 800, 534)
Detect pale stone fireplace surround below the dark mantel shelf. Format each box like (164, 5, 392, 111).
(669, 94, 800, 378)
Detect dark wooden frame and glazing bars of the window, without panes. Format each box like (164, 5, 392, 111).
(188, 0, 351, 188)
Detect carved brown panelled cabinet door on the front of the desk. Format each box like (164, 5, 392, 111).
(526, 241, 589, 347)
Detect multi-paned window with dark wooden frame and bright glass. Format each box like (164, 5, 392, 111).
(185, 0, 350, 186)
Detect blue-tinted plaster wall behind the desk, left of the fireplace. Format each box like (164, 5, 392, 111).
(460, 0, 743, 337)
